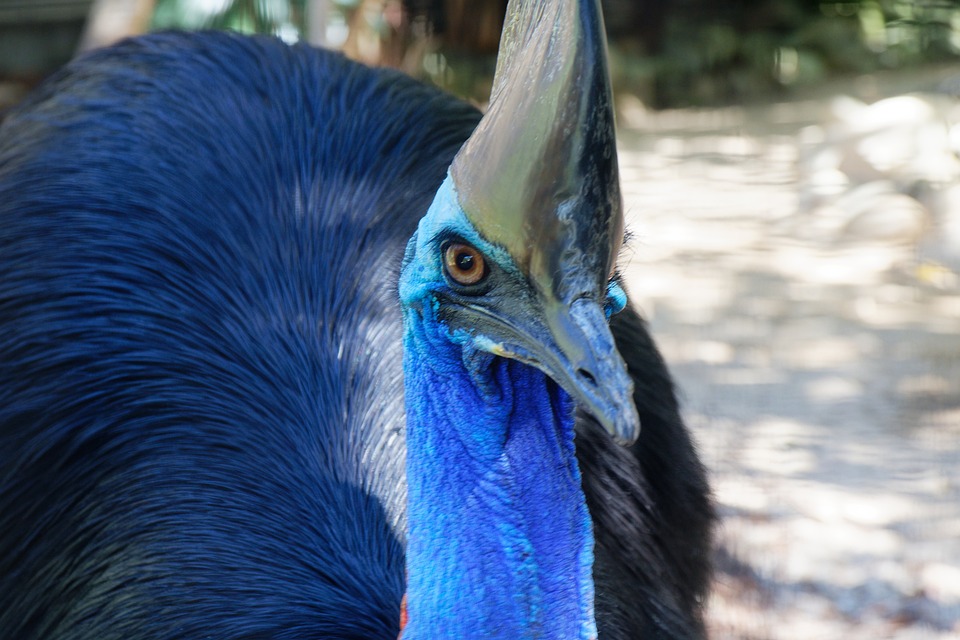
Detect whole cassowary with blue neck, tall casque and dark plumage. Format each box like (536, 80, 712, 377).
(0, 0, 712, 640)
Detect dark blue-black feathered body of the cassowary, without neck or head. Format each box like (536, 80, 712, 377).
(0, 34, 712, 640)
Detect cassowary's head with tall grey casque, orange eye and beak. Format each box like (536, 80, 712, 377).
(401, 0, 639, 443)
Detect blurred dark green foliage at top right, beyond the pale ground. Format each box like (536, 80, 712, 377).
(644, 0, 960, 105)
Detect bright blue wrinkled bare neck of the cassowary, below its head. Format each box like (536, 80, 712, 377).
(403, 311, 596, 640)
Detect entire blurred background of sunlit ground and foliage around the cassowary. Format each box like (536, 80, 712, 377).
(0, 0, 960, 640)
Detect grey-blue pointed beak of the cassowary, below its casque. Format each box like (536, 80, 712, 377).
(462, 290, 640, 445)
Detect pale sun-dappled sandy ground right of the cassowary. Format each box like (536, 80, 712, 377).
(620, 76, 960, 640)
